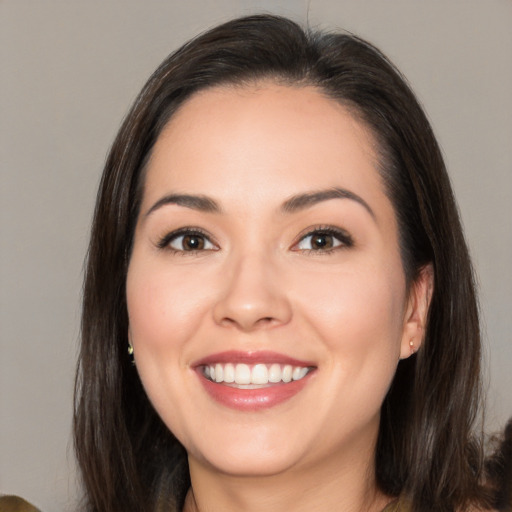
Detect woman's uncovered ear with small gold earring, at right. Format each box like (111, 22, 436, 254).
(400, 263, 434, 359)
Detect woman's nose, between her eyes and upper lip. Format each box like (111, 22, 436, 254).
(213, 250, 292, 332)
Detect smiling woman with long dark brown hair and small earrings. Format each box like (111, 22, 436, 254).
(75, 16, 510, 511)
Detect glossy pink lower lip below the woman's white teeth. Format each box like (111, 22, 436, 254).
(197, 371, 313, 411)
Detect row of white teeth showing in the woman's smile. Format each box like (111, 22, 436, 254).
(203, 363, 310, 385)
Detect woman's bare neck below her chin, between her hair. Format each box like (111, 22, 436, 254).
(184, 428, 391, 512)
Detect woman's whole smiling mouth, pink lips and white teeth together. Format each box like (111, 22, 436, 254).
(193, 351, 316, 411)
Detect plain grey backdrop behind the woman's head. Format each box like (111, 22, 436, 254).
(0, 0, 512, 512)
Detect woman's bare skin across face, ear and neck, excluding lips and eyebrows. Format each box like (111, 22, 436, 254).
(127, 82, 432, 512)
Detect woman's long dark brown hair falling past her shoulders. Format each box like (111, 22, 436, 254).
(74, 15, 496, 512)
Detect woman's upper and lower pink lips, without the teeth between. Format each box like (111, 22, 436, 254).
(193, 351, 315, 412)
